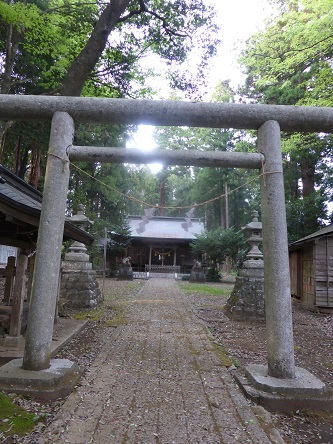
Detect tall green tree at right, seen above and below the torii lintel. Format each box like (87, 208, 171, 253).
(240, 0, 333, 240)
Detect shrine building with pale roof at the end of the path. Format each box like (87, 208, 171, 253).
(127, 216, 204, 273)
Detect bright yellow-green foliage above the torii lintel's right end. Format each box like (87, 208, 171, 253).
(240, 0, 333, 106)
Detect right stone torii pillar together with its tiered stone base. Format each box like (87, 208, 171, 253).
(235, 120, 333, 411)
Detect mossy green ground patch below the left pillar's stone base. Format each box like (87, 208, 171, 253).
(0, 392, 39, 442)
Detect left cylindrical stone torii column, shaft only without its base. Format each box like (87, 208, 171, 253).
(23, 111, 74, 370)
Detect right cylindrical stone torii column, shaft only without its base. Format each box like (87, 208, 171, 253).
(258, 120, 295, 379)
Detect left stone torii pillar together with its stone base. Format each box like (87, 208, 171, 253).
(0, 111, 80, 400)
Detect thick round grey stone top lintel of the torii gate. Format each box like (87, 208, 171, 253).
(0, 94, 333, 133)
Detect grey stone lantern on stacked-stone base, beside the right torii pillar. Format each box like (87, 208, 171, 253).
(225, 211, 265, 321)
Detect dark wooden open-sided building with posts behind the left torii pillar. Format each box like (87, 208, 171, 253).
(0, 165, 94, 337)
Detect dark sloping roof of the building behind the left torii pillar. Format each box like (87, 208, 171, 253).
(0, 164, 94, 248)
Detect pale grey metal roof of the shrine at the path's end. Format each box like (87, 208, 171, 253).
(129, 216, 204, 240)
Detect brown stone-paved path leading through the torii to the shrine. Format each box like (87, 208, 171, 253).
(38, 279, 283, 444)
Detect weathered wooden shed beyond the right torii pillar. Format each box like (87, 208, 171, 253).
(289, 224, 333, 308)
